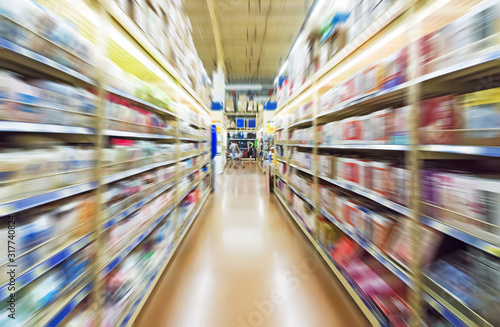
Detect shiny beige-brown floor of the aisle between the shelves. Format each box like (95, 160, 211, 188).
(135, 164, 368, 327)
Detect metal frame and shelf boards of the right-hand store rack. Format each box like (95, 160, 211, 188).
(274, 0, 500, 326)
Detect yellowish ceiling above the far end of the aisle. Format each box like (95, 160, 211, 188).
(184, 0, 313, 83)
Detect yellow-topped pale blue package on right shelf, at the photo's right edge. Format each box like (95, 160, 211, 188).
(460, 88, 500, 146)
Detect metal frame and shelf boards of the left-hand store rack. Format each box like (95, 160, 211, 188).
(0, 0, 211, 326)
